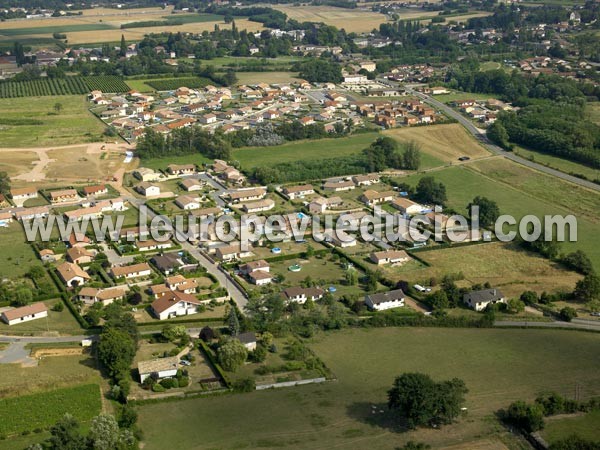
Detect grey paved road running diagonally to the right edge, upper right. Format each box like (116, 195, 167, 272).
(406, 87, 600, 191)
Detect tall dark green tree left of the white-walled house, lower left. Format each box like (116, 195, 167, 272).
(98, 328, 135, 378)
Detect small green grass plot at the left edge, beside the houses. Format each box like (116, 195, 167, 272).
(0, 222, 42, 279)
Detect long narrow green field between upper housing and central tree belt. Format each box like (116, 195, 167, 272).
(233, 133, 444, 170)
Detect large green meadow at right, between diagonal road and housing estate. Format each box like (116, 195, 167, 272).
(402, 158, 600, 267)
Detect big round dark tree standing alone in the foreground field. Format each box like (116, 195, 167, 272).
(388, 373, 467, 427)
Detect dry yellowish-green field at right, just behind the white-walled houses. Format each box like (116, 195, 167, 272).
(396, 243, 581, 297)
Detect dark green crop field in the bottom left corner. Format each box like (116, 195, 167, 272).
(0, 384, 101, 435)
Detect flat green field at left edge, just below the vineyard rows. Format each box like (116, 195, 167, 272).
(0, 95, 104, 147)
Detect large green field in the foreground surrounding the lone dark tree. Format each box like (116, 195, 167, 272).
(138, 328, 600, 450)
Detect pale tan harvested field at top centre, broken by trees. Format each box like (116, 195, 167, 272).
(273, 5, 422, 33)
